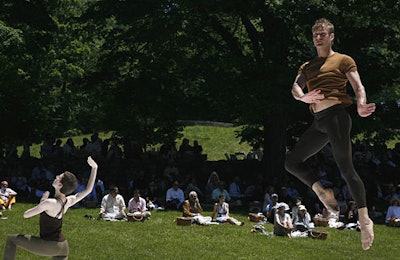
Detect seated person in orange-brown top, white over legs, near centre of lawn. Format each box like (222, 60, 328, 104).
(182, 191, 212, 225)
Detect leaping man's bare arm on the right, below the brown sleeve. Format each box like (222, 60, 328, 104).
(346, 71, 375, 117)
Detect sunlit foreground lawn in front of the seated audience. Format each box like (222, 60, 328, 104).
(0, 203, 400, 260)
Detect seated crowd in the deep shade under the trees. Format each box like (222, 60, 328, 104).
(0, 133, 400, 228)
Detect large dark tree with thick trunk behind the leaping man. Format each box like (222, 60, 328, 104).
(79, 0, 399, 174)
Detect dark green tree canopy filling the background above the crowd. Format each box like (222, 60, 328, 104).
(0, 0, 400, 168)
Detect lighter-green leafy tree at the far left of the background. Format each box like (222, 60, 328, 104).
(0, 0, 103, 144)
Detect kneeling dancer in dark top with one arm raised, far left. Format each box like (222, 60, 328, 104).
(3, 156, 97, 260)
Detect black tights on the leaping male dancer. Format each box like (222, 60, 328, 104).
(285, 105, 367, 208)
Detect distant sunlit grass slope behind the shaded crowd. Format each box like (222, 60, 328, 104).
(18, 126, 251, 161)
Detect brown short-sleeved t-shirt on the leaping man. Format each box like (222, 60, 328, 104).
(298, 52, 357, 106)
